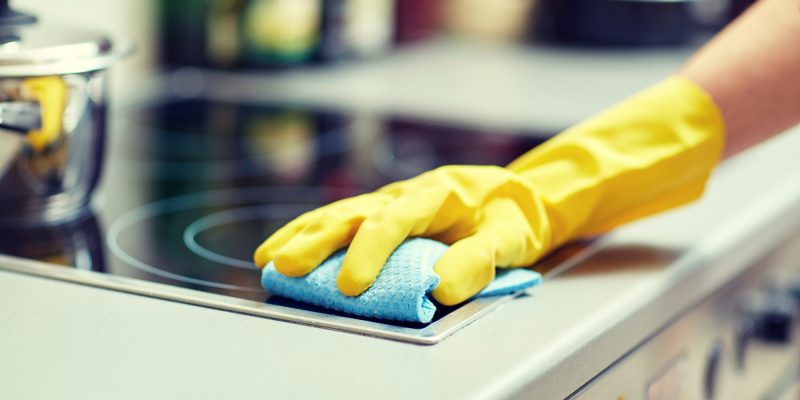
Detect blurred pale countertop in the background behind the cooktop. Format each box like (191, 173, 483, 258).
(166, 40, 696, 133)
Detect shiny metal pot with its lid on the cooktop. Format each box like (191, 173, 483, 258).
(0, 0, 132, 227)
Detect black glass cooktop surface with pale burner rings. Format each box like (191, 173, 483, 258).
(0, 99, 542, 324)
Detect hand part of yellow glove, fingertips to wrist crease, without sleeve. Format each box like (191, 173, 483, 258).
(255, 166, 551, 305)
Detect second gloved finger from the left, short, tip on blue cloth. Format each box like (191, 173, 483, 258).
(273, 212, 365, 277)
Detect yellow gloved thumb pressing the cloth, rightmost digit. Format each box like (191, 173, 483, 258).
(432, 231, 495, 306)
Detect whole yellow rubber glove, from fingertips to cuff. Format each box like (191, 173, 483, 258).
(255, 77, 724, 305)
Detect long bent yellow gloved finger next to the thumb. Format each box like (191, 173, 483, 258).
(337, 188, 464, 296)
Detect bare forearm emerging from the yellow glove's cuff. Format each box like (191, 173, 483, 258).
(681, 0, 800, 156)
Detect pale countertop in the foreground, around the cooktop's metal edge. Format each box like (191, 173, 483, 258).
(0, 40, 800, 399)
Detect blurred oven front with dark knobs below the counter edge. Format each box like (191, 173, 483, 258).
(571, 237, 800, 400)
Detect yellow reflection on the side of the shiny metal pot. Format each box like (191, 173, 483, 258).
(22, 76, 67, 151)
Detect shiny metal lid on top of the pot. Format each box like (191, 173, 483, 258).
(0, 0, 133, 77)
